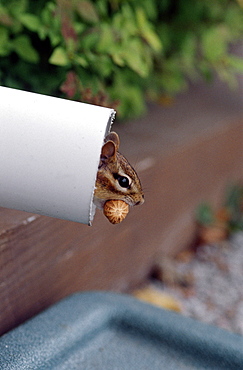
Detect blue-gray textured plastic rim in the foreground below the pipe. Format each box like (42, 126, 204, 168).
(0, 292, 243, 370)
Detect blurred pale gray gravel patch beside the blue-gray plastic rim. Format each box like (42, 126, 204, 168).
(158, 232, 243, 335)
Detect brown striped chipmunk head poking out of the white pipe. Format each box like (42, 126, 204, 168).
(93, 132, 144, 209)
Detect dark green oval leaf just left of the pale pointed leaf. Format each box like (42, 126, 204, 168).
(11, 35, 39, 63)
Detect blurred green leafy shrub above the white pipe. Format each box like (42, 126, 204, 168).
(0, 0, 243, 118)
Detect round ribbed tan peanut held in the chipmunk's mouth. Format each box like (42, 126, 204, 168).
(103, 199, 129, 224)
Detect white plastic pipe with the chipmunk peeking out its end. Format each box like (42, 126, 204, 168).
(0, 87, 115, 225)
